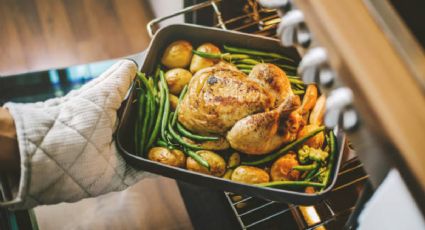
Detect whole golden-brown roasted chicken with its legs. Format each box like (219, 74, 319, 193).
(178, 63, 308, 155)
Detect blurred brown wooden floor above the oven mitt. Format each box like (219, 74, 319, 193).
(0, 0, 152, 75)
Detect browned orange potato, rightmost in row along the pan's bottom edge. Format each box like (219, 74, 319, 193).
(270, 152, 300, 181)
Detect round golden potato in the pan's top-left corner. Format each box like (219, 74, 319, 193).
(161, 40, 193, 69)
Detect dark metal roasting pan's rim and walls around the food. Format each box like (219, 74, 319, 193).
(115, 24, 345, 205)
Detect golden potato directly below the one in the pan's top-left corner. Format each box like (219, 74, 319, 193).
(165, 68, 192, 95)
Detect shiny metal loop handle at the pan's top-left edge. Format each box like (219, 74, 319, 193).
(146, 0, 226, 38)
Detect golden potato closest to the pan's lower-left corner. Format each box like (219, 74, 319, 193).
(148, 147, 186, 168)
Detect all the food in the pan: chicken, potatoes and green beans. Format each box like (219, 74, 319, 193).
(134, 40, 336, 193)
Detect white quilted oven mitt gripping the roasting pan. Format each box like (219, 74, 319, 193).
(0, 60, 146, 209)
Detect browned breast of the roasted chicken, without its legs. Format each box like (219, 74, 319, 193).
(178, 63, 272, 135)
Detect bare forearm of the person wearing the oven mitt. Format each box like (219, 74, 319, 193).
(0, 107, 20, 172)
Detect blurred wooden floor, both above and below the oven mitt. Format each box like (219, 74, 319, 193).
(0, 0, 192, 230)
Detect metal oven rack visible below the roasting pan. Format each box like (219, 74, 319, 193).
(226, 157, 369, 229)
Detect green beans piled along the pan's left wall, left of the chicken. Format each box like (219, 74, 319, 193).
(135, 67, 220, 170)
